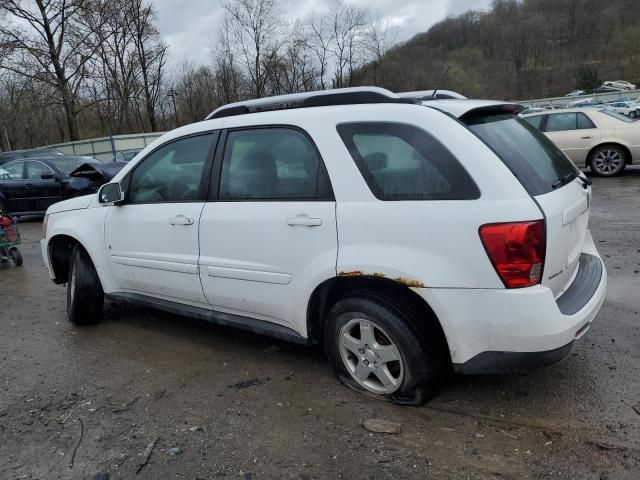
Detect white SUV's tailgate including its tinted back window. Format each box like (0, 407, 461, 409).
(461, 113, 591, 297)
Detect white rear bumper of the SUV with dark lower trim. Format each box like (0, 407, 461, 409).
(415, 231, 607, 373)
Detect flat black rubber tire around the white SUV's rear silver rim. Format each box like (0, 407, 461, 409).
(324, 291, 450, 405)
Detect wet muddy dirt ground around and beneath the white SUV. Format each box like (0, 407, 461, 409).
(0, 169, 640, 480)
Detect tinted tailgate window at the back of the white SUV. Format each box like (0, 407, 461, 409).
(461, 112, 579, 196)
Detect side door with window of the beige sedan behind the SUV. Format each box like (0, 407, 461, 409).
(543, 112, 601, 167)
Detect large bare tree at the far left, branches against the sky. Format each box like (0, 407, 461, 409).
(0, 0, 103, 140)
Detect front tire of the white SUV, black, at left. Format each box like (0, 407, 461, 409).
(67, 245, 104, 325)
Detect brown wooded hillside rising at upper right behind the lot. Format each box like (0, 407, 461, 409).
(356, 0, 640, 99)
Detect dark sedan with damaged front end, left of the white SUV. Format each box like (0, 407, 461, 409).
(0, 156, 122, 216)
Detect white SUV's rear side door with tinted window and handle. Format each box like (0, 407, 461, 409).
(200, 127, 338, 332)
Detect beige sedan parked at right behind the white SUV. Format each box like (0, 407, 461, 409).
(524, 108, 640, 177)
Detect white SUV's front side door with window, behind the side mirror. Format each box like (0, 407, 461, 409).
(105, 132, 217, 306)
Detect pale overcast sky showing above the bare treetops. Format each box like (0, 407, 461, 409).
(153, 0, 491, 72)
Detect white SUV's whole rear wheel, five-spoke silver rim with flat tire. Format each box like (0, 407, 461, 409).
(325, 293, 446, 405)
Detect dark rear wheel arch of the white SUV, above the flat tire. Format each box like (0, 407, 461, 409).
(307, 272, 451, 361)
